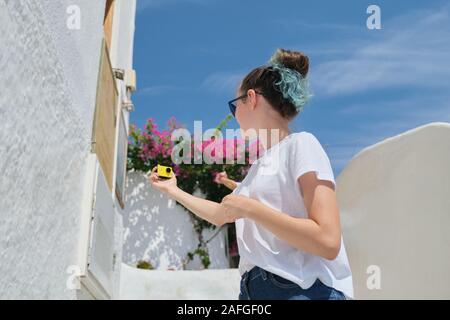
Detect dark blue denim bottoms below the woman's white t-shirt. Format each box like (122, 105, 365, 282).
(239, 266, 346, 300)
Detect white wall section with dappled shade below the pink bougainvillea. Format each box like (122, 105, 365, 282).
(122, 171, 229, 270)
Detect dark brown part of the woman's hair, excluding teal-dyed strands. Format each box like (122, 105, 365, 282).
(240, 48, 309, 120)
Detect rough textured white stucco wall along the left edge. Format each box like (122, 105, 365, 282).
(0, 0, 104, 299)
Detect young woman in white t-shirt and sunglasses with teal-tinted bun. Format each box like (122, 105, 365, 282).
(149, 49, 353, 300)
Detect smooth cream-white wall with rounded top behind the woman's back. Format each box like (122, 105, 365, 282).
(336, 123, 450, 299)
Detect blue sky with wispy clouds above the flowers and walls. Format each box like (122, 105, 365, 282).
(131, 0, 450, 177)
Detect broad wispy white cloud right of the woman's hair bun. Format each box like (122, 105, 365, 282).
(312, 7, 450, 95)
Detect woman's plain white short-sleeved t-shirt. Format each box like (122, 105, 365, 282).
(233, 131, 353, 298)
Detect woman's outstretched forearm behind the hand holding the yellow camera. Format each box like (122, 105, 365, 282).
(169, 188, 225, 227)
